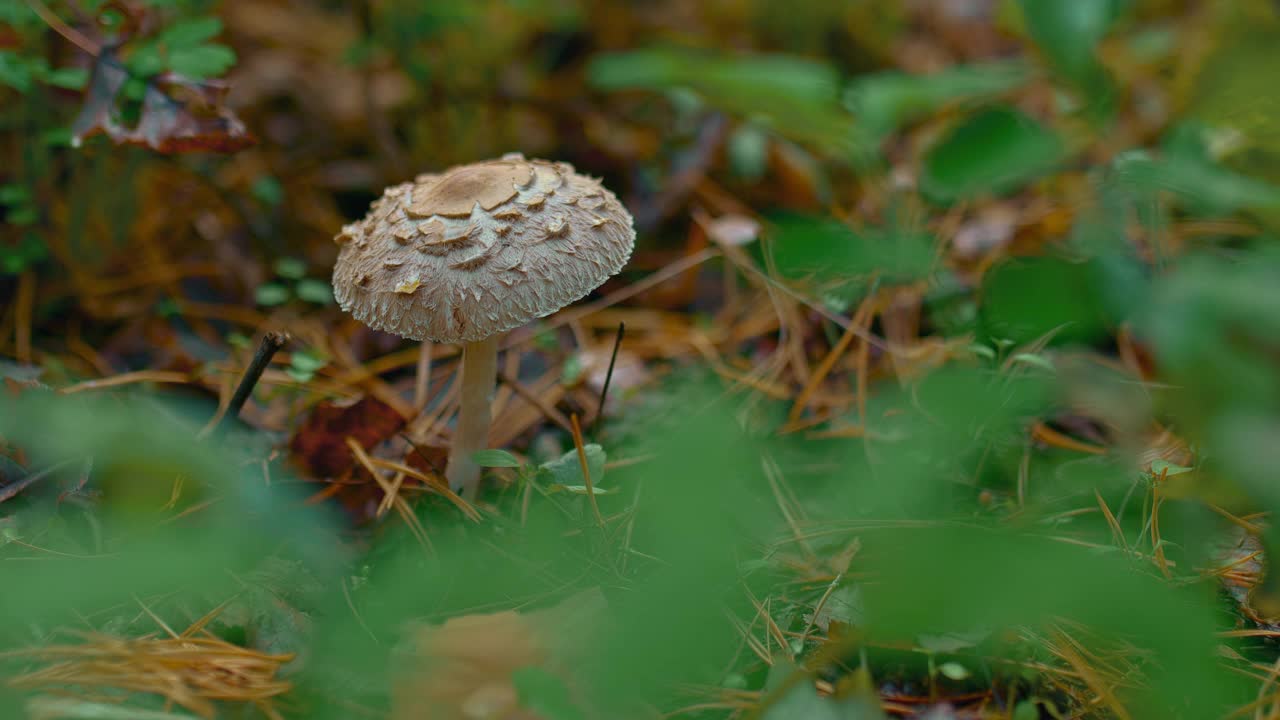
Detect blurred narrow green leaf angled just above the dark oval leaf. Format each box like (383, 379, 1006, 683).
(845, 61, 1030, 136)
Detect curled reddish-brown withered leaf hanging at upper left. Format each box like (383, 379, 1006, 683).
(72, 46, 256, 154)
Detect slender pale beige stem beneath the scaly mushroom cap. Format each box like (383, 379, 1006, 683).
(444, 336, 498, 500)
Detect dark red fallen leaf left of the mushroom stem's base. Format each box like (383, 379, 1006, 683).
(289, 396, 404, 478)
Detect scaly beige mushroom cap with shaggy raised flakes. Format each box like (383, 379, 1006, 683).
(333, 154, 635, 343)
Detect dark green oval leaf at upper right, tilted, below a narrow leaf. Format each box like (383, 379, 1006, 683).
(920, 108, 1065, 204)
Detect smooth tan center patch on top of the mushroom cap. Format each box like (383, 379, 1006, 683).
(407, 161, 534, 218)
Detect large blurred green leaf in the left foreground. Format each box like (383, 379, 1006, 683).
(0, 391, 344, 623)
